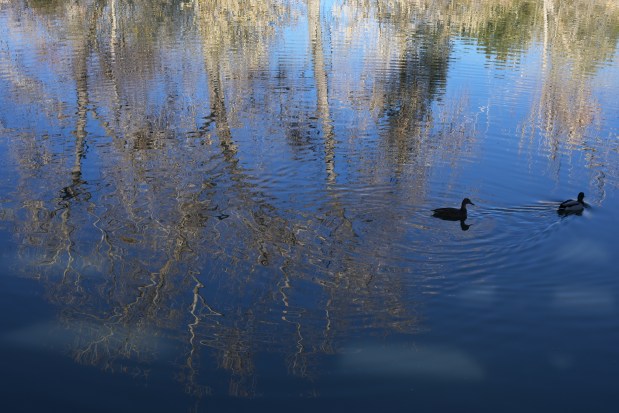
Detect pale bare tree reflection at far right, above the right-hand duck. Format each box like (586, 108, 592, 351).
(522, 0, 619, 194)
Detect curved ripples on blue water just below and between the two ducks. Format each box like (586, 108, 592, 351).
(410, 199, 580, 284)
